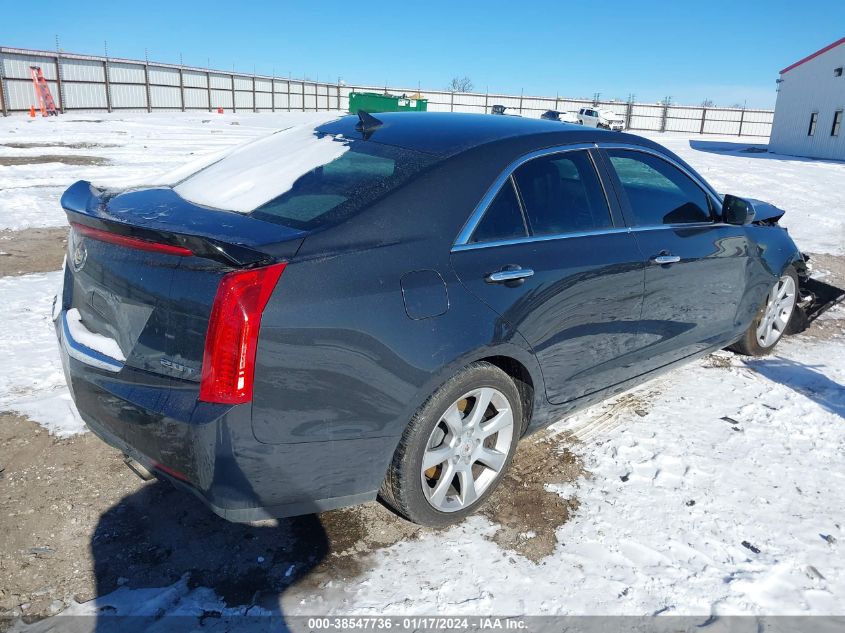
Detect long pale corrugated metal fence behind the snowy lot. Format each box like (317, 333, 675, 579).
(0, 47, 774, 137)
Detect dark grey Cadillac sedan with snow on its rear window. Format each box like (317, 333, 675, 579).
(54, 113, 806, 525)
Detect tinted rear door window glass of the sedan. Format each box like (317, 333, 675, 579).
(514, 151, 613, 235)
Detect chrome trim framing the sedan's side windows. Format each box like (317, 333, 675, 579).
(452, 142, 726, 252)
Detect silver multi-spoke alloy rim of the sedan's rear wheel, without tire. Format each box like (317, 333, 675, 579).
(420, 387, 513, 512)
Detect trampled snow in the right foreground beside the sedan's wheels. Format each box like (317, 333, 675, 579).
(283, 334, 845, 616)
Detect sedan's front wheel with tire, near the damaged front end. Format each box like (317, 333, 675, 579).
(729, 266, 798, 356)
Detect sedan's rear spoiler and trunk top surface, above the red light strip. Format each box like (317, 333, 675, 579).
(61, 180, 306, 268)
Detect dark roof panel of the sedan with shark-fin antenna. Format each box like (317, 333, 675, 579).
(317, 112, 640, 157)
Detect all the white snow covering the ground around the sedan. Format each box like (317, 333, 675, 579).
(0, 113, 845, 615)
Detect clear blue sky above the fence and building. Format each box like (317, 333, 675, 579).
(6, 0, 845, 107)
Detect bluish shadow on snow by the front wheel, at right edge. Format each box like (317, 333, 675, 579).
(745, 356, 845, 418)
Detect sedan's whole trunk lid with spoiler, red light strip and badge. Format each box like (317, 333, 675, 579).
(59, 181, 305, 383)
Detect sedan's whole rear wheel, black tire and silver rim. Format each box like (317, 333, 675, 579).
(379, 362, 523, 527)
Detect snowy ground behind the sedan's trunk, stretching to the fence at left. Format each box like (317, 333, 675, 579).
(0, 112, 337, 230)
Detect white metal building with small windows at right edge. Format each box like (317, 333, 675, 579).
(769, 37, 845, 160)
